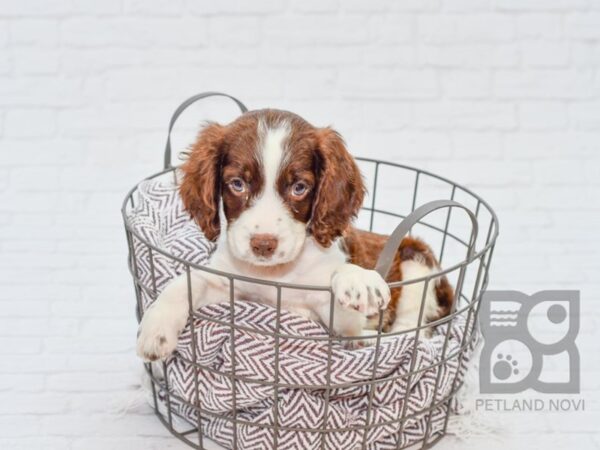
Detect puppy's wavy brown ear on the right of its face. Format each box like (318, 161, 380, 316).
(308, 128, 365, 247)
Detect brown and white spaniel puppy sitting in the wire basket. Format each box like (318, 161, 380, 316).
(137, 109, 453, 360)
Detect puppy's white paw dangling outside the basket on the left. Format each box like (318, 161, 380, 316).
(136, 305, 179, 361)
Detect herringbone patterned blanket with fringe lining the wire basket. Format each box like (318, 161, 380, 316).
(130, 178, 468, 450)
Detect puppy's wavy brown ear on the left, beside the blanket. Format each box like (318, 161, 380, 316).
(179, 123, 225, 241)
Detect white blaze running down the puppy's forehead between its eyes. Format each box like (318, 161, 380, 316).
(258, 121, 290, 193)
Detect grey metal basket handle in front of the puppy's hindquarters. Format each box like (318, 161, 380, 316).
(375, 200, 479, 279)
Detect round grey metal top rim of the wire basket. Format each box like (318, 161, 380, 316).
(121, 156, 500, 294)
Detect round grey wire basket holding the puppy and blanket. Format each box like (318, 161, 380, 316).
(122, 93, 498, 449)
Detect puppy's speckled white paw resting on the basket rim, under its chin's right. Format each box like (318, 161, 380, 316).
(331, 264, 391, 316)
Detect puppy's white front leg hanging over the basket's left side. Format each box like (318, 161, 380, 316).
(136, 271, 223, 361)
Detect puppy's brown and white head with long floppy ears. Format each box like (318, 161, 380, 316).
(180, 110, 365, 266)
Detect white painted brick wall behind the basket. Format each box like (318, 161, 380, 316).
(0, 0, 600, 450)
